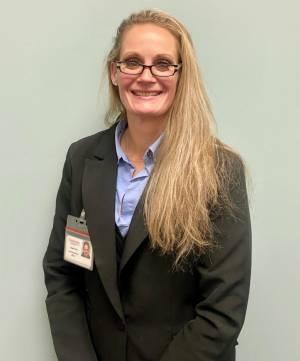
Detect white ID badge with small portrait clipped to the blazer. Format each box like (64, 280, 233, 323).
(64, 211, 94, 271)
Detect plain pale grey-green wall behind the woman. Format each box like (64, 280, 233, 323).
(0, 0, 300, 361)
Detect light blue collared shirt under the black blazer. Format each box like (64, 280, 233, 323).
(115, 120, 162, 237)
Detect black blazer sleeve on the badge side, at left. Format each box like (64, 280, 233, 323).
(43, 146, 98, 361)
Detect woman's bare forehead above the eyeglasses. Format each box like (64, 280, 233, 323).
(120, 24, 178, 58)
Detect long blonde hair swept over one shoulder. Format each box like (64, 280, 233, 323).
(106, 9, 241, 265)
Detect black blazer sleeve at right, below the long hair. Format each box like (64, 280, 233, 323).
(160, 160, 251, 361)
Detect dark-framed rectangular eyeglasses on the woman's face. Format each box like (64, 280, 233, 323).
(114, 60, 182, 77)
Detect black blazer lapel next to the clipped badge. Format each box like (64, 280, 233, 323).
(82, 127, 124, 320)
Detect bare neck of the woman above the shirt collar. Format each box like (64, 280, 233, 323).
(121, 117, 165, 159)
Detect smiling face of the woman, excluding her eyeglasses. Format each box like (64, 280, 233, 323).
(111, 24, 179, 119)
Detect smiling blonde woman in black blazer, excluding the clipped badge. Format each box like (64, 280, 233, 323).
(44, 10, 251, 361)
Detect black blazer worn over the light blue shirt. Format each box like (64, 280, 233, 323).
(44, 126, 251, 361)
